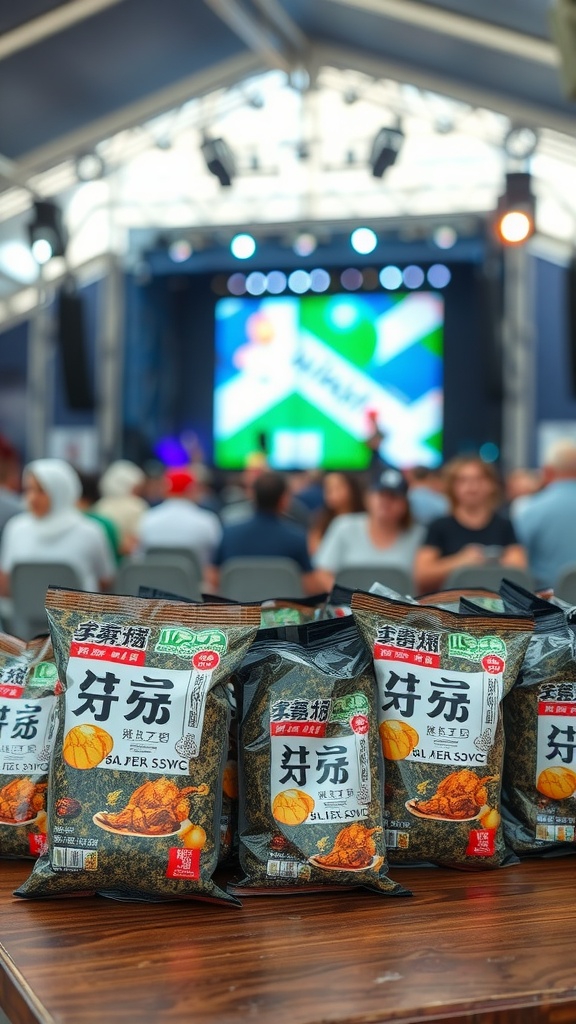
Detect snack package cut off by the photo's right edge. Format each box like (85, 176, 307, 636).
(501, 582, 576, 855)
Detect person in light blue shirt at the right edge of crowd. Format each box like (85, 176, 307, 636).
(513, 439, 576, 588)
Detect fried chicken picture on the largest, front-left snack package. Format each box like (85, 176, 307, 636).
(98, 778, 208, 836)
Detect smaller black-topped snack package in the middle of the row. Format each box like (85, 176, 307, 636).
(229, 615, 406, 894)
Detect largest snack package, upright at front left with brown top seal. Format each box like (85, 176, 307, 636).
(16, 588, 259, 902)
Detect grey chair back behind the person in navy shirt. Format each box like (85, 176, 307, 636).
(218, 557, 304, 601)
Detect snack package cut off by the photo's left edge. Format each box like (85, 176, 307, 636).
(0, 633, 59, 857)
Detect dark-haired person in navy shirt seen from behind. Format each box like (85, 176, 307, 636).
(204, 470, 322, 594)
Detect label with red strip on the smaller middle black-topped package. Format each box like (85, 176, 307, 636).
(271, 694, 371, 824)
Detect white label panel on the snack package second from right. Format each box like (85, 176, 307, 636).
(374, 643, 503, 767)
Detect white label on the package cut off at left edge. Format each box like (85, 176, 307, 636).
(0, 696, 56, 775)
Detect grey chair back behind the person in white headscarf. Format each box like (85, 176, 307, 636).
(10, 562, 82, 640)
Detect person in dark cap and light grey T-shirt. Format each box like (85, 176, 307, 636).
(314, 467, 424, 590)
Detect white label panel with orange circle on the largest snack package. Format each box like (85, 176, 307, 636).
(64, 655, 217, 775)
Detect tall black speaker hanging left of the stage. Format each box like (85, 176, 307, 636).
(56, 290, 94, 411)
